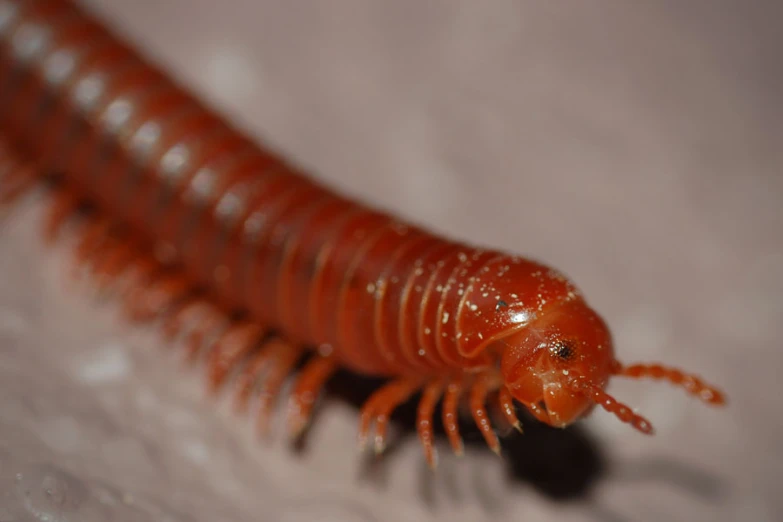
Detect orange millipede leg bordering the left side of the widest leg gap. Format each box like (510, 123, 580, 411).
(288, 355, 338, 438)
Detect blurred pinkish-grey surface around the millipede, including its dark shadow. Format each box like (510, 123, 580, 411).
(0, 0, 783, 522)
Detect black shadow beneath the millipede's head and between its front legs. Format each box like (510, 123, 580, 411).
(328, 371, 607, 500)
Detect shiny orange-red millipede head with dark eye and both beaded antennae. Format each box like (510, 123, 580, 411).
(500, 300, 726, 434)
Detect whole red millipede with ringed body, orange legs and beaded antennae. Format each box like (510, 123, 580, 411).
(0, 0, 725, 465)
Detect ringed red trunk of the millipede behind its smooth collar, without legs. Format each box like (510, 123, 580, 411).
(2, 2, 543, 375)
